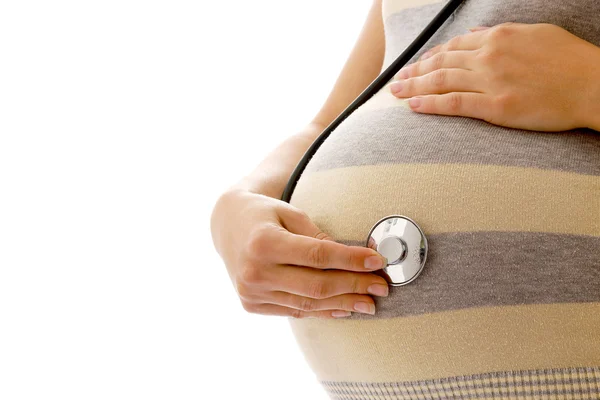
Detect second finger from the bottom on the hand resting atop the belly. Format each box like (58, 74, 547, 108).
(390, 69, 481, 98)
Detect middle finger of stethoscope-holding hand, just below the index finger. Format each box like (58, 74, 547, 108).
(264, 265, 389, 299)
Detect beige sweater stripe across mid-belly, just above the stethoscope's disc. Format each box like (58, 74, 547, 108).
(291, 164, 600, 241)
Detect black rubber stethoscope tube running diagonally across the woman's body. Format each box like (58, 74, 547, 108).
(281, 0, 464, 203)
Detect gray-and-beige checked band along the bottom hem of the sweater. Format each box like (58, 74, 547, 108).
(321, 367, 600, 400)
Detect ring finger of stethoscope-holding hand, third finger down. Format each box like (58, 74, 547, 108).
(267, 291, 375, 315)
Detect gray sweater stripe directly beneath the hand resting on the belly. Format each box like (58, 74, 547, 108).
(306, 107, 600, 176)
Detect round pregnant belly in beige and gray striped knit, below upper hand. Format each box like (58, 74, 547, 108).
(290, 88, 600, 399)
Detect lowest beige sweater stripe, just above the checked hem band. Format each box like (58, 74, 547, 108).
(289, 303, 600, 382)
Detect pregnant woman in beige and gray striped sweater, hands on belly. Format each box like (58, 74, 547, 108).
(212, 0, 600, 400)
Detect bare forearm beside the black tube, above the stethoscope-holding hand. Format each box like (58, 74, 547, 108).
(230, 123, 325, 199)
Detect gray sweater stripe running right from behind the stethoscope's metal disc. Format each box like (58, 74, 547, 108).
(332, 232, 600, 319)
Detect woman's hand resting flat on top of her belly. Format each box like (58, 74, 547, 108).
(391, 23, 600, 132)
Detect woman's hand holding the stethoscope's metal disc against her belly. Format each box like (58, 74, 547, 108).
(211, 190, 388, 318)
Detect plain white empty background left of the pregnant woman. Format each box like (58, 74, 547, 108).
(0, 0, 370, 400)
